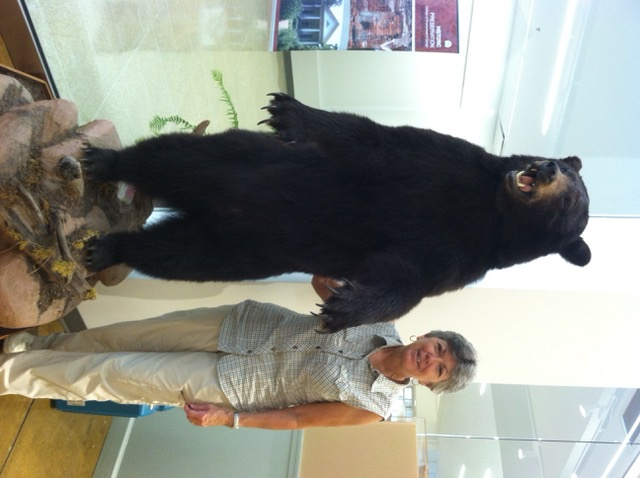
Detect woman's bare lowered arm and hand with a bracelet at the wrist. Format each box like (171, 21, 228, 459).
(184, 402, 382, 430)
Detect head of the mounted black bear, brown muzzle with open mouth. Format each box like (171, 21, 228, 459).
(499, 156, 591, 266)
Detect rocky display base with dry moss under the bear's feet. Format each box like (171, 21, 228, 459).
(0, 75, 153, 328)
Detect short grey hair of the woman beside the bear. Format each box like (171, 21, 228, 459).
(424, 330, 477, 393)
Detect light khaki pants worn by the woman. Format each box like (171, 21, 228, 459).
(0, 306, 233, 408)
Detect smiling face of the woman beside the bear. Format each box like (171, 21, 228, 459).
(402, 337, 458, 386)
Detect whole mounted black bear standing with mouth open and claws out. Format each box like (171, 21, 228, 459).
(85, 94, 591, 331)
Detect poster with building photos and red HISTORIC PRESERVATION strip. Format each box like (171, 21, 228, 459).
(271, 0, 458, 53)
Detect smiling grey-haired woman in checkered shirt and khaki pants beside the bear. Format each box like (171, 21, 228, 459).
(0, 278, 476, 429)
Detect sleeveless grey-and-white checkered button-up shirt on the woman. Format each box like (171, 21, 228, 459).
(218, 300, 404, 418)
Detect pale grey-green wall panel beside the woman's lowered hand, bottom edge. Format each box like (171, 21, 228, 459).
(110, 408, 301, 478)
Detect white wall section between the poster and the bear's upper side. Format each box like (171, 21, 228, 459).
(291, 0, 515, 148)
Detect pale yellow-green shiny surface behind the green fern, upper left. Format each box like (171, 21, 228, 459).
(25, 0, 286, 145)
